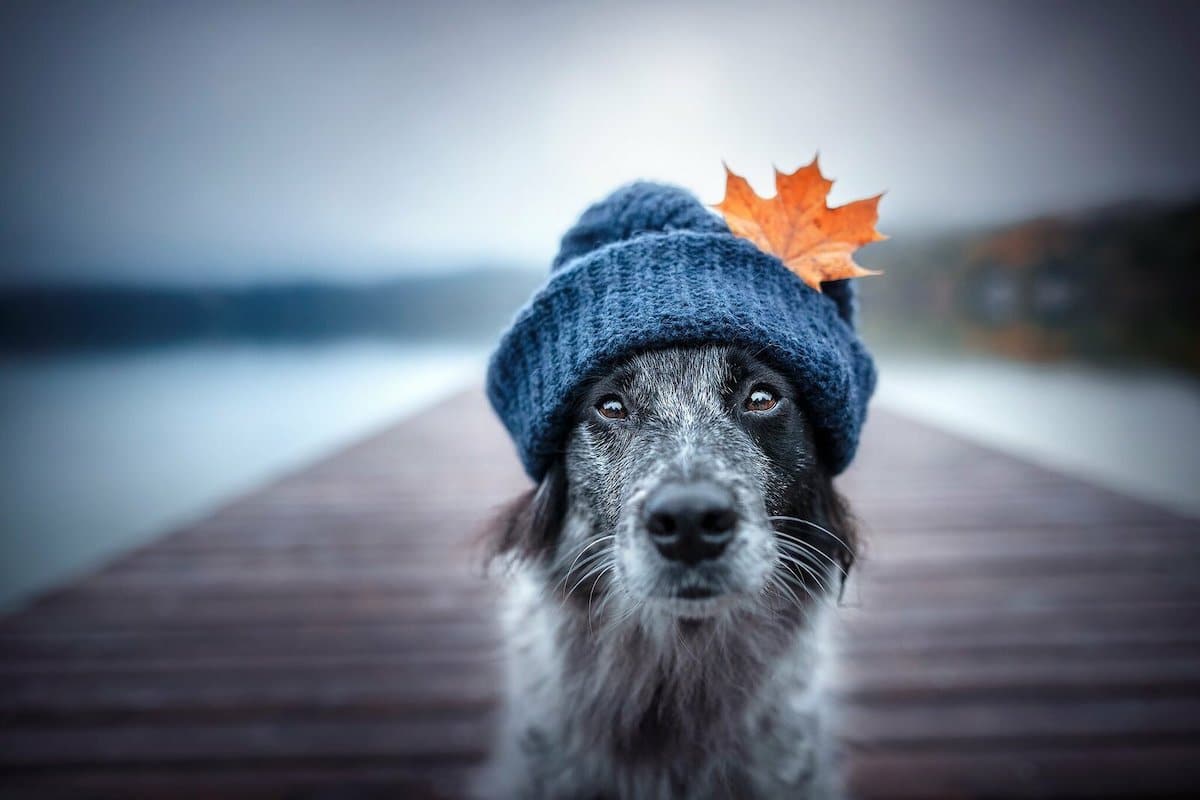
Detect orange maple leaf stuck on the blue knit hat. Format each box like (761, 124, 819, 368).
(713, 158, 887, 291)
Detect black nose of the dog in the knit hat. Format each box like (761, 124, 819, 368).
(646, 481, 738, 564)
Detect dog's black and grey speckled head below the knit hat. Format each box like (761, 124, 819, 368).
(499, 347, 854, 624)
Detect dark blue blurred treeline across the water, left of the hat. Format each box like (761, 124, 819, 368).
(0, 269, 541, 353)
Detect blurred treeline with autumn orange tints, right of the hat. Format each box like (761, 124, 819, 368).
(860, 199, 1200, 372)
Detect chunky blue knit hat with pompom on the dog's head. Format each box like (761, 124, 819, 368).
(487, 184, 875, 480)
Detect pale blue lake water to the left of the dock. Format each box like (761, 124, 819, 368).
(0, 343, 484, 607)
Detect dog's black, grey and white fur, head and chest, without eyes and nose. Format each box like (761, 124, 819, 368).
(479, 347, 856, 800)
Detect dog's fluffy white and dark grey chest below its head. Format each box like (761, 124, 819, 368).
(492, 573, 828, 800)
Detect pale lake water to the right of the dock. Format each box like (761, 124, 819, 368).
(876, 356, 1200, 517)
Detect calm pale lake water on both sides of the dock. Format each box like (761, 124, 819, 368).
(0, 343, 1200, 607)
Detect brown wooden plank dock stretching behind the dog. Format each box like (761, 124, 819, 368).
(0, 392, 1200, 799)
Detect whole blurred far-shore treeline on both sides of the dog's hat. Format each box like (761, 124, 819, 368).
(7, 199, 1200, 372)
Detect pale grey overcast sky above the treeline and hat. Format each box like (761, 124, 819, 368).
(0, 1, 1200, 283)
